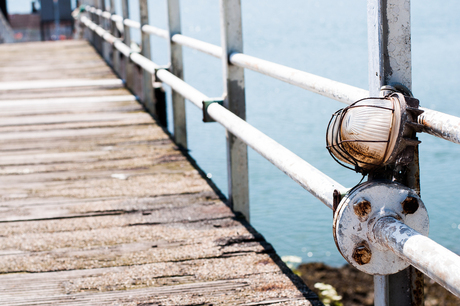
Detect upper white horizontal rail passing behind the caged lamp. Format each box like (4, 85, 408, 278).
(88, 8, 460, 144)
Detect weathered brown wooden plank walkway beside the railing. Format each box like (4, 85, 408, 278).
(0, 41, 320, 305)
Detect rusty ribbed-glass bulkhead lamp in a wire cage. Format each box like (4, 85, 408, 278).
(326, 91, 423, 173)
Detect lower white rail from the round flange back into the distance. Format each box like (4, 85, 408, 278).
(81, 16, 347, 209)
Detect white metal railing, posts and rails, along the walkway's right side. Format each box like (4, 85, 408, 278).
(78, 0, 460, 305)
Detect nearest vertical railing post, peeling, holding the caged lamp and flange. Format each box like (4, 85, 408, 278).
(368, 0, 423, 306)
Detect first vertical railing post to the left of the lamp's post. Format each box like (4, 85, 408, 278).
(220, 0, 249, 221)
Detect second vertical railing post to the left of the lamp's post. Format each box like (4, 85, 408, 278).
(168, 0, 187, 149)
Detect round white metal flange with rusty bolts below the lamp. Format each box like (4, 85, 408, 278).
(333, 181, 429, 275)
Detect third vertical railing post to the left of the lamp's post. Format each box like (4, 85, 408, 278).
(139, 0, 157, 112)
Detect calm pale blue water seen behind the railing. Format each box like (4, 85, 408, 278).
(10, 0, 460, 265)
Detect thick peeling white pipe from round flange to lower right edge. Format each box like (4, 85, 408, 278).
(373, 217, 460, 297)
